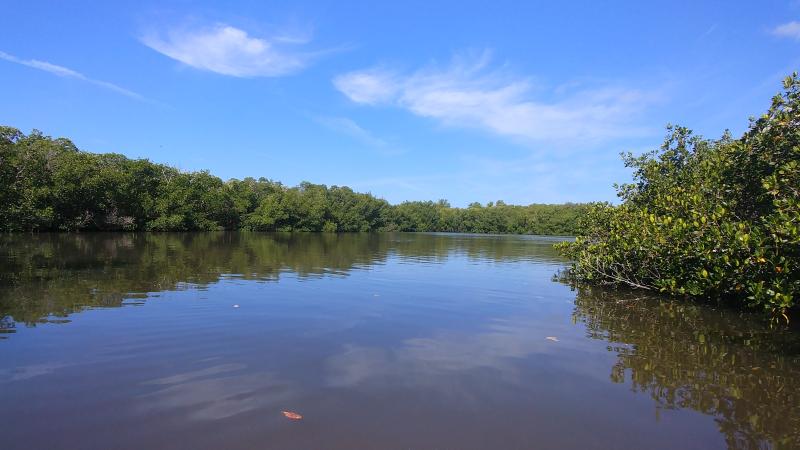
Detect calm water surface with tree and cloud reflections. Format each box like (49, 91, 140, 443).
(0, 233, 800, 450)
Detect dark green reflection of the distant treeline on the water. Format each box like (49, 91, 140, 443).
(0, 232, 560, 326)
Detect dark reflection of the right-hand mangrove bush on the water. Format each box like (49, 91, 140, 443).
(573, 288, 800, 449)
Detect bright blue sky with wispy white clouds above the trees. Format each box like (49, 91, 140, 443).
(0, 0, 800, 206)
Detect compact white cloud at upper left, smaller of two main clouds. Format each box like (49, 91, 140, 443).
(141, 24, 310, 77)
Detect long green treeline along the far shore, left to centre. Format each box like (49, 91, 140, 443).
(0, 126, 588, 235)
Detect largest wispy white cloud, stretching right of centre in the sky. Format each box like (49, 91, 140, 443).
(333, 52, 653, 142)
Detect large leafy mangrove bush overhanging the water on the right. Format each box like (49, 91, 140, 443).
(557, 73, 800, 322)
